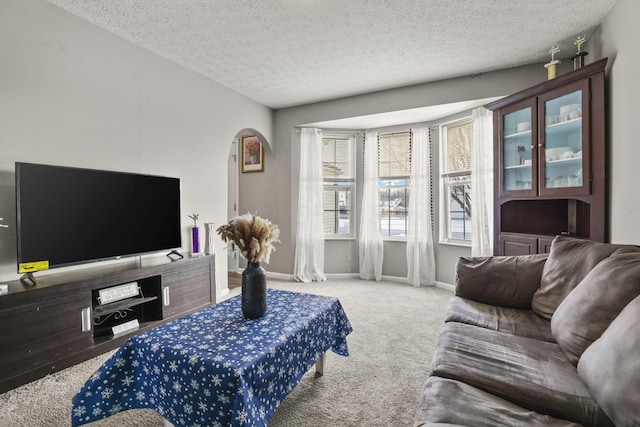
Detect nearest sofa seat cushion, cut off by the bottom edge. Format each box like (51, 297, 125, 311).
(414, 376, 579, 427)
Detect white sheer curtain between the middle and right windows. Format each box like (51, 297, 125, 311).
(407, 128, 436, 286)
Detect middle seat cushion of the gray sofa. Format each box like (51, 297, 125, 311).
(431, 322, 612, 426)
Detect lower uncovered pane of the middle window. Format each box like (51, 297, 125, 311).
(380, 180, 409, 236)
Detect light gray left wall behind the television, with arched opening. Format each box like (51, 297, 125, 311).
(0, 0, 272, 294)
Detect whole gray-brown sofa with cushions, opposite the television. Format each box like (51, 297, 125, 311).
(415, 236, 640, 427)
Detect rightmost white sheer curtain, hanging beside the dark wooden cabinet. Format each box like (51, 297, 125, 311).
(471, 107, 493, 256)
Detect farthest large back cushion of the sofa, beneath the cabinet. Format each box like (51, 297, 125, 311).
(531, 236, 623, 319)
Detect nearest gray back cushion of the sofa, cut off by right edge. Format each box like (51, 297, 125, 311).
(578, 297, 640, 426)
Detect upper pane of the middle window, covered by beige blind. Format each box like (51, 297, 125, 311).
(378, 132, 411, 178)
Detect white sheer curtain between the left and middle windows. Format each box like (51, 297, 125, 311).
(358, 132, 383, 280)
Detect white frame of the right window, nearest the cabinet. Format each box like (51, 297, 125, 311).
(438, 116, 473, 247)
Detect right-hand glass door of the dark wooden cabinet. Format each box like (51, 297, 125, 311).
(540, 81, 589, 194)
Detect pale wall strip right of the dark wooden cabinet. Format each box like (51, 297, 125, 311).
(589, 0, 640, 245)
